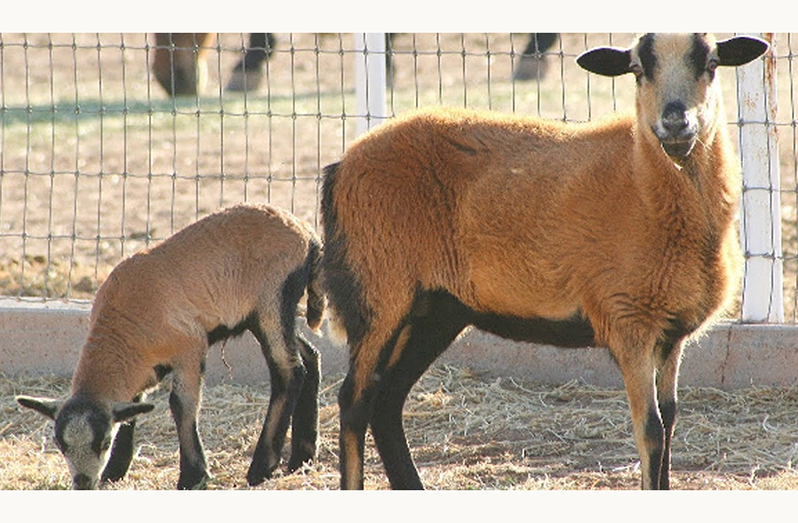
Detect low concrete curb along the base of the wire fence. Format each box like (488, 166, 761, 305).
(0, 300, 798, 390)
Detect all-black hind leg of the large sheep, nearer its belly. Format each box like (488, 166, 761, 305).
(371, 295, 468, 489)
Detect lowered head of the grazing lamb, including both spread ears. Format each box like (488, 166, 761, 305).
(17, 396, 153, 490)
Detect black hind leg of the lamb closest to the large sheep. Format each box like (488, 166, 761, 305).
(288, 335, 321, 472)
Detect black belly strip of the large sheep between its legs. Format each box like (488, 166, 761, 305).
(471, 313, 595, 347)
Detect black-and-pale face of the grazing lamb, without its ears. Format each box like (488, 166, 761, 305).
(55, 397, 116, 490)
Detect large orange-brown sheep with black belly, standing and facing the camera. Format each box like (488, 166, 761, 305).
(322, 34, 768, 489)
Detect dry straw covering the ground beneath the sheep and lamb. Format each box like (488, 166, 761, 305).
(0, 366, 798, 490)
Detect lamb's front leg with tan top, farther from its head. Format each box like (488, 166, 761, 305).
(169, 355, 210, 490)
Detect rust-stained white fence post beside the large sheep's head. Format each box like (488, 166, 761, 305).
(737, 33, 784, 323)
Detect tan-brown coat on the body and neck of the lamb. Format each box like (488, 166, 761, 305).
(72, 205, 319, 401)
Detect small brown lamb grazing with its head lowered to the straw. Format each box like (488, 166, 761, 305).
(17, 205, 324, 489)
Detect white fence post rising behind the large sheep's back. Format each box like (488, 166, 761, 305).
(354, 33, 387, 135)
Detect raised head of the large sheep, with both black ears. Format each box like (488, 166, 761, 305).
(577, 33, 768, 162)
